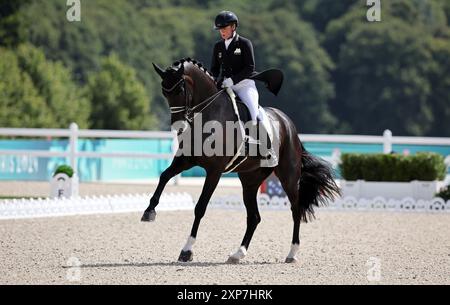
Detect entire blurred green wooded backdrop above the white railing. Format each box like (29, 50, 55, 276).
(0, 0, 450, 136)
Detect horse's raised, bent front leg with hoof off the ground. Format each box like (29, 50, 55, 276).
(141, 156, 192, 221)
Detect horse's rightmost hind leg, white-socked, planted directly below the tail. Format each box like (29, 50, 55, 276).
(275, 154, 301, 263)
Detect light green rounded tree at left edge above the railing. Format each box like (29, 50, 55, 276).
(0, 45, 89, 128)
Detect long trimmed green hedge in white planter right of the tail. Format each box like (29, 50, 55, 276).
(340, 152, 446, 182)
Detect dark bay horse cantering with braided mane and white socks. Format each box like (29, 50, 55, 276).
(141, 59, 340, 263)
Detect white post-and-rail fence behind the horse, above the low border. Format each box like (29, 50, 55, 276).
(0, 123, 450, 178)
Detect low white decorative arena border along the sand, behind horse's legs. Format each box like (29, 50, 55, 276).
(0, 193, 450, 219)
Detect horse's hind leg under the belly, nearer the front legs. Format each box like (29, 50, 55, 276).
(228, 168, 273, 263)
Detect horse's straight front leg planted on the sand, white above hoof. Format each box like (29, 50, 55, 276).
(178, 171, 222, 262)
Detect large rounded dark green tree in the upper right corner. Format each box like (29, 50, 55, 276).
(323, 0, 450, 135)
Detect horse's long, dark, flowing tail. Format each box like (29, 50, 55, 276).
(299, 144, 341, 222)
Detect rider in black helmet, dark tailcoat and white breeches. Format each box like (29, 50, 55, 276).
(211, 11, 272, 157)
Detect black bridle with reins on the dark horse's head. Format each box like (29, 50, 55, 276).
(162, 77, 224, 124)
